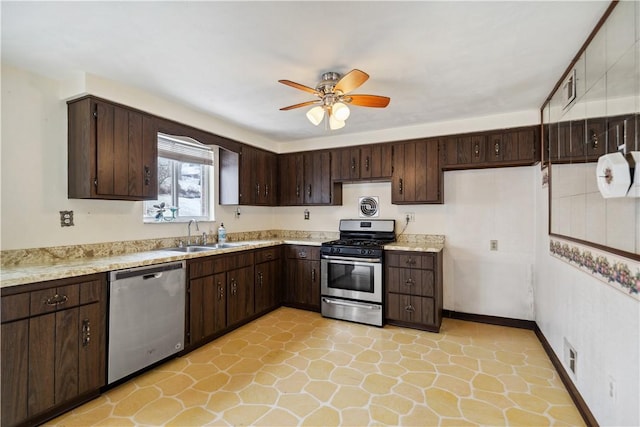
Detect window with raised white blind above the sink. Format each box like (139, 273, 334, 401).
(144, 134, 213, 222)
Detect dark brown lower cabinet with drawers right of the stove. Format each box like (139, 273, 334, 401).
(385, 251, 442, 332)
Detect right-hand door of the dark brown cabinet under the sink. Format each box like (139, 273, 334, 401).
(227, 266, 254, 326)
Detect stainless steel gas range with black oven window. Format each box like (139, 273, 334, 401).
(320, 219, 395, 326)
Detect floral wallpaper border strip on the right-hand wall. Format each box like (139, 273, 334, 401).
(549, 239, 640, 301)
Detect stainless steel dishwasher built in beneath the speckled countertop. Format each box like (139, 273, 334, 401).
(107, 261, 186, 384)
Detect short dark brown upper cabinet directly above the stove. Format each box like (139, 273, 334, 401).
(331, 144, 391, 182)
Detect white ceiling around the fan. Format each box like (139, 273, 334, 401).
(1, 0, 609, 142)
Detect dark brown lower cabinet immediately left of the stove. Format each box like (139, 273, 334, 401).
(284, 245, 320, 311)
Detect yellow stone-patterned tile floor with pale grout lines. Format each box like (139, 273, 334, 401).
(47, 308, 584, 426)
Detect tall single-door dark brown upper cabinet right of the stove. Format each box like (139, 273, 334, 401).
(391, 139, 443, 204)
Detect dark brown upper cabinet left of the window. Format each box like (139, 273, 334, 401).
(68, 97, 158, 200)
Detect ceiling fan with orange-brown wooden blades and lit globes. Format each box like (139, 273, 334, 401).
(278, 69, 391, 130)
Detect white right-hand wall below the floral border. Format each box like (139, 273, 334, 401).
(534, 166, 640, 426)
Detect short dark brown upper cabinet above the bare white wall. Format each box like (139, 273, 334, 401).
(441, 126, 540, 170)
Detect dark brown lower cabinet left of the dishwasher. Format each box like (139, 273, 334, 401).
(1, 275, 107, 427)
